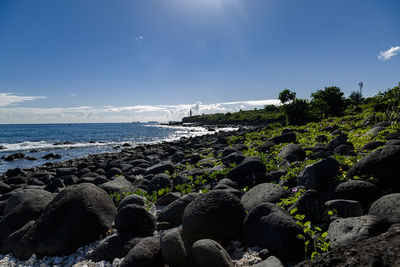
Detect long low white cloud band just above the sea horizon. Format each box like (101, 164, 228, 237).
(0, 99, 279, 123)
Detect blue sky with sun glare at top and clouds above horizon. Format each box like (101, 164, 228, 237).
(0, 0, 400, 123)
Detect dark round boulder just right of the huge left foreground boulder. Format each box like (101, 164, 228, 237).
(115, 204, 156, 237)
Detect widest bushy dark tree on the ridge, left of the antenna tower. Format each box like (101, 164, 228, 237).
(311, 86, 346, 118)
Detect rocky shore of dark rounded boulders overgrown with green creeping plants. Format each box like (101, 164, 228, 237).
(0, 120, 400, 267)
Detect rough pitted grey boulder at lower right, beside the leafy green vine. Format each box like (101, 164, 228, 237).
(327, 215, 383, 248)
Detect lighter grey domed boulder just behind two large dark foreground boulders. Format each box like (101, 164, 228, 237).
(241, 183, 289, 211)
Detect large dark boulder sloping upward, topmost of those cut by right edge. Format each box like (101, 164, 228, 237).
(347, 145, 400, 187)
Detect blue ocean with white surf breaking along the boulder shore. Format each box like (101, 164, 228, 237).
(0, 123, 222, 173)
